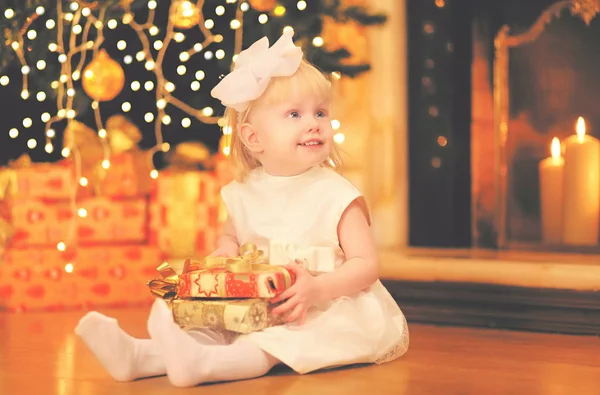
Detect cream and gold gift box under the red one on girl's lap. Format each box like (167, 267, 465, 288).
(170, 299, 285, 333)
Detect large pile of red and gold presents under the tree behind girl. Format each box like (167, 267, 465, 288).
(0, 117, 233, 311)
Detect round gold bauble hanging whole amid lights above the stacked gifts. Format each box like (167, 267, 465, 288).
(81, 49, 125, 101)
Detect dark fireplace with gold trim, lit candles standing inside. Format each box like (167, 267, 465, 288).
(407, 0, 600, 253)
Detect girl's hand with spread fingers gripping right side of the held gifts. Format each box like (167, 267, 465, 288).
(271, 264, 320, 325)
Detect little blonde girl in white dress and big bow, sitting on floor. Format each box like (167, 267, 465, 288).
(75, 31, 408, 386)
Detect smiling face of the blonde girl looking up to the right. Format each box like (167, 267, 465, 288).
(251, 86, 333, 176)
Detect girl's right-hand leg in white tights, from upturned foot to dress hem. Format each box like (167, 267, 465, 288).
(148, 299, 279, 387)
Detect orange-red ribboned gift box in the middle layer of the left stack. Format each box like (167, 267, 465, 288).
(4, 198, 148, 248)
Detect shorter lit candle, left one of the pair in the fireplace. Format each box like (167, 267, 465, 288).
(539, 137, 565, 244)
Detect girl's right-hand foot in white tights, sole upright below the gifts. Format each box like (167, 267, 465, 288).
(148, 299, 210, 387)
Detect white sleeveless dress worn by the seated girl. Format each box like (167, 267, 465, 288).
(221, 166, 408, 373)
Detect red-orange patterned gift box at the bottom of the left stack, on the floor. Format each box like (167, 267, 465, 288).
(0, 246, 162, 311)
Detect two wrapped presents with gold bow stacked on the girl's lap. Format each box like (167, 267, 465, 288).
(148, 244, 295, 334)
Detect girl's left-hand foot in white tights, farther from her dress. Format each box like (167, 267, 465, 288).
(75, 311, 165, 381)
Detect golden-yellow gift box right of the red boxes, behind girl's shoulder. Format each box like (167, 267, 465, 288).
(149, 170, 221, 258)
